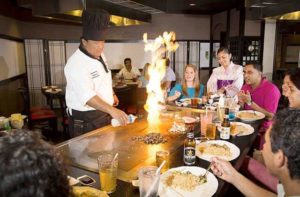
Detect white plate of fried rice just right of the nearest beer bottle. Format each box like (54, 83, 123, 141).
(196, 140, 240, 161)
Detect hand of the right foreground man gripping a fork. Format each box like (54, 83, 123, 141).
(211, 157, 238, 183)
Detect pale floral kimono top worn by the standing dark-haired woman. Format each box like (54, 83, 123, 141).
(207, 62, 244, 93)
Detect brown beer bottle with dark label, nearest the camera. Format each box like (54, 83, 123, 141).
(183, 132, 196, 165)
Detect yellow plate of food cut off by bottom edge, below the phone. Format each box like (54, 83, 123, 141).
(72, 186, 108, 197)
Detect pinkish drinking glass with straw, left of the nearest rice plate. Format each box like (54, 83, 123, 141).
(138, 166, 160, 197)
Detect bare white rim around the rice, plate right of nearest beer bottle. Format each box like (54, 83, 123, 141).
(196, 140, 240, 162)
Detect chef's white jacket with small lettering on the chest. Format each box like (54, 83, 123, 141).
(64, 49, 114, 111)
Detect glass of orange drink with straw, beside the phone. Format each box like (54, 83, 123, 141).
(98, 152, 118, 194)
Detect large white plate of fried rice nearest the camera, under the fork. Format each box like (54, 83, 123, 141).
(158, 166, 218, 197)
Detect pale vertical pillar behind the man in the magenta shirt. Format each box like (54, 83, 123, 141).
(263, 19, 276, 80)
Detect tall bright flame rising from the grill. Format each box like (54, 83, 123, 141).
(143, 32, 179, 125)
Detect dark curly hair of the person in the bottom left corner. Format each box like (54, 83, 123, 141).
(0, 130, 71, 197)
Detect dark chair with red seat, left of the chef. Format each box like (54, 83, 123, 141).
(18, 87, 57, 132)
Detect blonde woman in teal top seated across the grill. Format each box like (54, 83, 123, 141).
(167, 64, 204, 102)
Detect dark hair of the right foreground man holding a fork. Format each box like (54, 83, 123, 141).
(270, 109, 300, 179)
